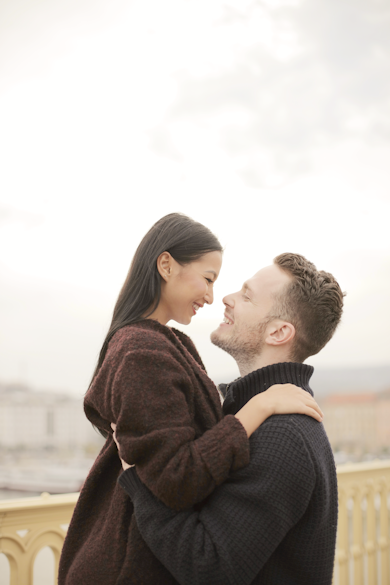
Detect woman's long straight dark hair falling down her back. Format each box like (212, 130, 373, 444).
(90, 213, 222, 406)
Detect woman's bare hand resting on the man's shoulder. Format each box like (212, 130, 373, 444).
(236, 384, 324, 437)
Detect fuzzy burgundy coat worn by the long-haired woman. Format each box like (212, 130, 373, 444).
(58, 319, 249, 585)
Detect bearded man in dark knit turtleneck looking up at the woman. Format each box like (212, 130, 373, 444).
(114, 254, 343, 585)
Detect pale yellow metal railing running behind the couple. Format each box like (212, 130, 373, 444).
(0, 461, 390, 585)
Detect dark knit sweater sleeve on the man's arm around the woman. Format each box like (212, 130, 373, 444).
(119, 419, 315, 585)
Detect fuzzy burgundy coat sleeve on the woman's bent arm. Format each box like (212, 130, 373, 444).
(111, 350, 249, 510)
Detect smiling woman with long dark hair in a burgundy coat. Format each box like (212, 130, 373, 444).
(59, 214, 321, 585)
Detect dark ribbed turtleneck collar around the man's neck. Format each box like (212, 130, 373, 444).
(222, 362, 314, 414)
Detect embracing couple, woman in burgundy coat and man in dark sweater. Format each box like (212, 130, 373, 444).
(59, 213, 343, 585)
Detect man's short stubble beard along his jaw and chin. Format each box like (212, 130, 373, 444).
(210, 320, 269, 369)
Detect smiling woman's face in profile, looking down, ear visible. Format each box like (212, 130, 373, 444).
(154, 252, 222, 325)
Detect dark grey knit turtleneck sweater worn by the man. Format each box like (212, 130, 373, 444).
(119, 363, 337, 585)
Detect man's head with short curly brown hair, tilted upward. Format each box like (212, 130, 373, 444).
(211, 253, 344, 371)
